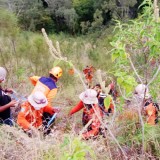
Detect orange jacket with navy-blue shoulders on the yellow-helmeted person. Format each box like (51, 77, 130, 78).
(30, 76, 57, 106)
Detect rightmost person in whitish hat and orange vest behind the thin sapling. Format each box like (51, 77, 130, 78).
(135, 84, 159, 125)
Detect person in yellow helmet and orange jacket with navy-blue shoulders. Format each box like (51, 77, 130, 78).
(30, 66, 62, 106)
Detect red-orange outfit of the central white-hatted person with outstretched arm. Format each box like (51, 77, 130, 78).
(69, 101, 102, 139)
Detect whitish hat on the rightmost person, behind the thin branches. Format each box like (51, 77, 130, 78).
(135, 84, 151, 99)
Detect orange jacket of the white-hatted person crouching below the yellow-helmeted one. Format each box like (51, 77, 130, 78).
(17, 101, 55, 130)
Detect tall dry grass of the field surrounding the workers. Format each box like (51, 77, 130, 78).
(0, 7, 160, 160)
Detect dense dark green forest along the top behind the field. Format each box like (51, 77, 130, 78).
(0, 0, 150, 34)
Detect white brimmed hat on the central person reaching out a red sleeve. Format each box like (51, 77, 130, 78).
(79, 89, 98, 104)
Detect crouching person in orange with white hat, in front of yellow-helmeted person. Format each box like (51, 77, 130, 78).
(17, 91, 55, 136)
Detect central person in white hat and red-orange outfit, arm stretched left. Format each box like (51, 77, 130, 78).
(69, 89, 102, 139)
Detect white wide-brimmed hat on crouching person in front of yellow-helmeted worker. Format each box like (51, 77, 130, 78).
(28, 91, 48, 110)
